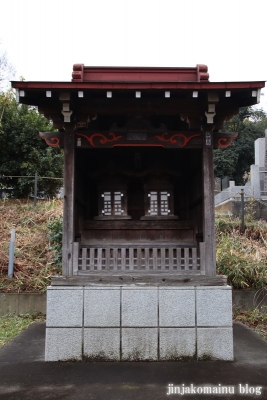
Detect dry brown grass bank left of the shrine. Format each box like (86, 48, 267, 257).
(0, 199, 62, 292)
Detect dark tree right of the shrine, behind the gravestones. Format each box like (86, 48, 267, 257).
(214, 107, 267, 185)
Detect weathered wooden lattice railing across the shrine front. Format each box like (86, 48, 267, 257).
(73, 242, 204, 275)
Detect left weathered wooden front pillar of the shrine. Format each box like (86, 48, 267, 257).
(62, 130, 75, 276)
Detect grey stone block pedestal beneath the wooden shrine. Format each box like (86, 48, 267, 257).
(45, 285, 233, 361)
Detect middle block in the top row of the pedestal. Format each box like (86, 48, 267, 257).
(122, 288, 158, 327)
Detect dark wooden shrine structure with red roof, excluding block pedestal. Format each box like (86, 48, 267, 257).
(13, 64, 264, 282)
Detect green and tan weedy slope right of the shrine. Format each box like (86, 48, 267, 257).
(215, 216, 267, 289)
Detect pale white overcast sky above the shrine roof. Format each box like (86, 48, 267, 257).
(0, 0, 267, 111)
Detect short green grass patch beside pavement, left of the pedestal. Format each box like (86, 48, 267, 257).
(0, 313, 45, 347)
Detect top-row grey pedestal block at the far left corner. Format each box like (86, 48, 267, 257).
(46, 287, 83, 327)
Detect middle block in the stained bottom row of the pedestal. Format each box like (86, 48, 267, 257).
(122, 328, 158, 361)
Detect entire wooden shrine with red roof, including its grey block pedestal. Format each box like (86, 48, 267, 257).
(12, 64, 264, 361)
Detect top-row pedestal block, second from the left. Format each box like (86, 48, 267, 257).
(84, 287, 120, 327)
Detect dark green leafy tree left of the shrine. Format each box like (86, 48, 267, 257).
(0, 91, 63, 197)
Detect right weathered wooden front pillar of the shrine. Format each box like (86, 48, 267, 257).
(203, 132, 216, 276)
